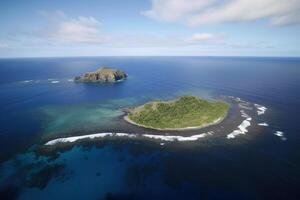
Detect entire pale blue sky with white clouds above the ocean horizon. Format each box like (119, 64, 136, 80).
(0, 0, 300, 58)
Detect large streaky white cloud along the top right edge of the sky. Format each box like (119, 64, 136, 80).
(143, 0, 300, 26)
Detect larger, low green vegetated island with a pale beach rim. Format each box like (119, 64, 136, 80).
(124, 96, 229, 130)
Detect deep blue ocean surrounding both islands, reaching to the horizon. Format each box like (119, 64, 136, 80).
(0, 57, 300, 199)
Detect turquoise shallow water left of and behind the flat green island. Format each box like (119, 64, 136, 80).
(37, 90, 212, 137)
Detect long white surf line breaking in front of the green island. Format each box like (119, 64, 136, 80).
(45, 131, 213, 145)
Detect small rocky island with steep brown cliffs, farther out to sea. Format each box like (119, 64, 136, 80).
(74, 67, 127, 82)
